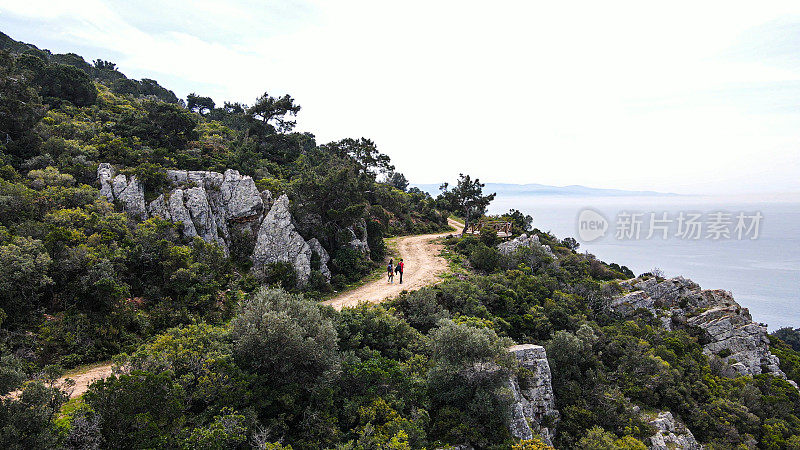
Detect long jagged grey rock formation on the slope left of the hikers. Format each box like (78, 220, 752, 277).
(97, 163, 334, 284)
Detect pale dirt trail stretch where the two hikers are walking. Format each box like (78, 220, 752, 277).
(322, 219, 463, 310)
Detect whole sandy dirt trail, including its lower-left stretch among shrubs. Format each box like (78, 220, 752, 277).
(4, 219, 463, 398)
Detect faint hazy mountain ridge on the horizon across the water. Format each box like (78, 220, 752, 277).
(411, 183, 679, 197)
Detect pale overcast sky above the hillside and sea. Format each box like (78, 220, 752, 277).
(0, 0, 800, 193)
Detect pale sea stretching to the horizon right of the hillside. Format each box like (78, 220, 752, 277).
(489, 192, 800, 331)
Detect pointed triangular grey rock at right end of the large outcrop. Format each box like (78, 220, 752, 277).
(253, 195, 311, 285)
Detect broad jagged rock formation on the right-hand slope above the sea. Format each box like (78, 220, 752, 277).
(609, 277, 786, 379)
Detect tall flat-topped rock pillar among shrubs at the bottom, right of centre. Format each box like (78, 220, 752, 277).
(508, 344, 559, 445)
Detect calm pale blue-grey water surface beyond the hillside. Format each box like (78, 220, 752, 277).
(490, 194, 800, 331)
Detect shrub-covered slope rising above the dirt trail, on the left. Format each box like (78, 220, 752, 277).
(0, 35, 447, 370)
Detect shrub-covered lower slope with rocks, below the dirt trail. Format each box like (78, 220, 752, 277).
(7, 220, 800, 449)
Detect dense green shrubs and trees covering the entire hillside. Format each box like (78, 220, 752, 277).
(0, 32, 800, 449)
